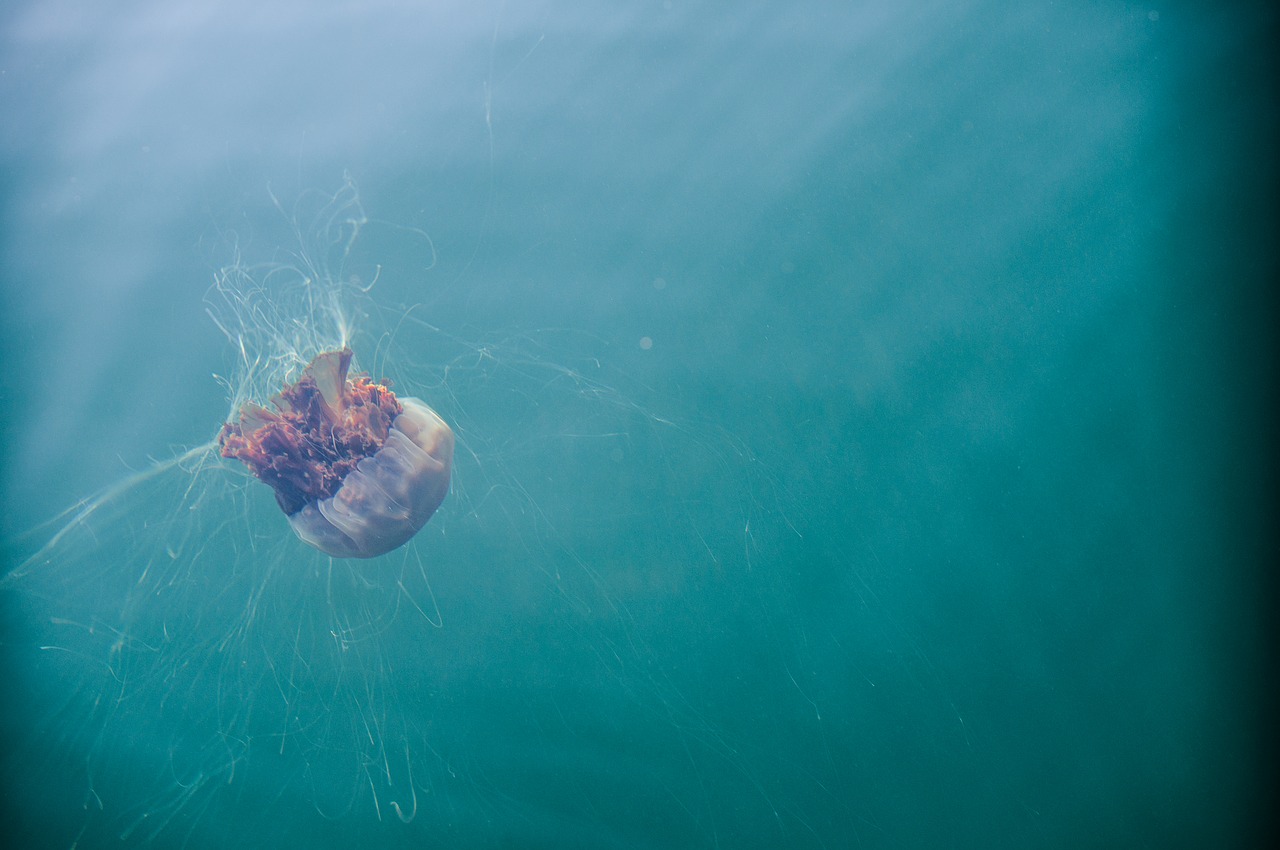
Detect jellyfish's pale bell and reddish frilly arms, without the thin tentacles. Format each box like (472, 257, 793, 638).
(218, 348, 453, 558)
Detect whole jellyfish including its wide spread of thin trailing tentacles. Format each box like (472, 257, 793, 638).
(0, 184, 774, 847)
